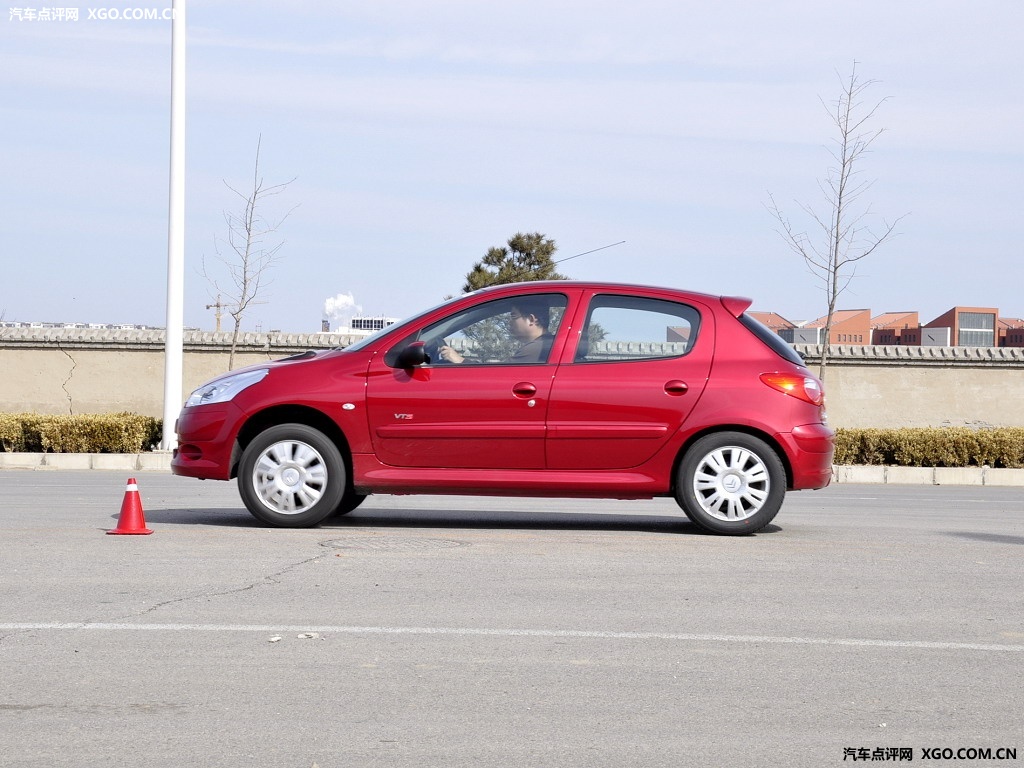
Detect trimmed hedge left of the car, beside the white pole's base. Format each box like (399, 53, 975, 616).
(0, 413, 163, 454)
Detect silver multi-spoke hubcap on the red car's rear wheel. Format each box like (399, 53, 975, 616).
(693, 445, 771, 520)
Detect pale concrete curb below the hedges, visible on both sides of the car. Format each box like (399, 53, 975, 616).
(0, 451, 1024, 487)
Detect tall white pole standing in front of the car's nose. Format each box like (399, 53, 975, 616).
(160, 0, 185, 451)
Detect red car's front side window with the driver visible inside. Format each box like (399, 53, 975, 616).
(387, 294, 567, 366)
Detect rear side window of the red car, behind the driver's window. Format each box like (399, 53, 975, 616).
(575, 295, 700, 362)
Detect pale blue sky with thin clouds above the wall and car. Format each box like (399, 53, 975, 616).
(0, 0, 1024, 332)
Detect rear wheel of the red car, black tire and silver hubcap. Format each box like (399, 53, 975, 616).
(676, 432, 785, 536)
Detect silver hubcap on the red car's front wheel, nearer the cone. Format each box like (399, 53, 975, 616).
(253, 440, 328, 515)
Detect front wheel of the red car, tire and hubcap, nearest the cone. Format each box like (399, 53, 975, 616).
(239, 424, 355, 528)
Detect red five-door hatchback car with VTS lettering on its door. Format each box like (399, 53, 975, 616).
(171, 281, 835, 535)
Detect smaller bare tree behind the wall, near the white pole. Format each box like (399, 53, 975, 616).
(203, 135, 297, 370)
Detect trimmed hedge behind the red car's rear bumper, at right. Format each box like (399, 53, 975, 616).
(835, 427, 1024, 467)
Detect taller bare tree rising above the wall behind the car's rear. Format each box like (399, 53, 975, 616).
(768, 61, 903, 378)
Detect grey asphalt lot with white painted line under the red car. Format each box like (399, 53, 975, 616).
(0, 471, 1024, 768)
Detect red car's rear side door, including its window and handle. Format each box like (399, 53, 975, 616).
(546, 292, 715, 469)
